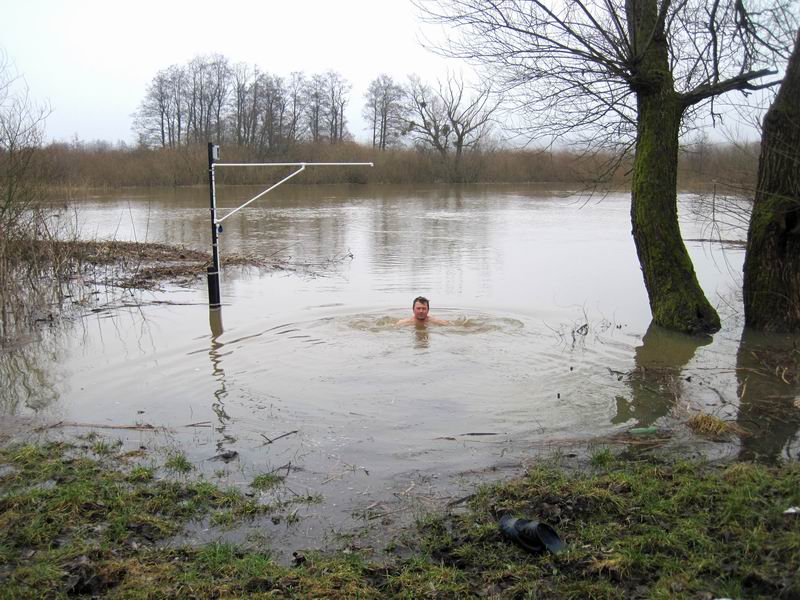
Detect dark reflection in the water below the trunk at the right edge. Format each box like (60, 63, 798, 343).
(736, 330, 800, 461)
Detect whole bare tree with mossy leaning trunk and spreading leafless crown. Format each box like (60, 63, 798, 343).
(419, 0, 796, 333)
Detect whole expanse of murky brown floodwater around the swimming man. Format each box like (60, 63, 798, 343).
(2, 186, 800, 546)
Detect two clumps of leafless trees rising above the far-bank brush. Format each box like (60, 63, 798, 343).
(133, 54, 499, 160)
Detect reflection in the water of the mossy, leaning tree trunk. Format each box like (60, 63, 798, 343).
(611, 323, 712, 427)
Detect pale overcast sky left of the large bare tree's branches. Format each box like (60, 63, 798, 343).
(0, 0, 456, 142)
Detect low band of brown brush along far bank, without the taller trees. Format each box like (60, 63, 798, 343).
(35, 142, 758, 189)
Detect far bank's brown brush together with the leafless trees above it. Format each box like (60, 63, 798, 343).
(90, 54, 757, 191)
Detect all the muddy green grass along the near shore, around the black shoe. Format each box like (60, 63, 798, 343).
(0, 441, 800, 598)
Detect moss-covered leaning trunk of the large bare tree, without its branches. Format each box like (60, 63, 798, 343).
(628, 0, 720, 333)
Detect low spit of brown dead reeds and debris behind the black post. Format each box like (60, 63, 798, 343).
(0, 239, 353, 348)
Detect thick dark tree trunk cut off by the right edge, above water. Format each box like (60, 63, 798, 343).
(744, 31, 800, 332)
